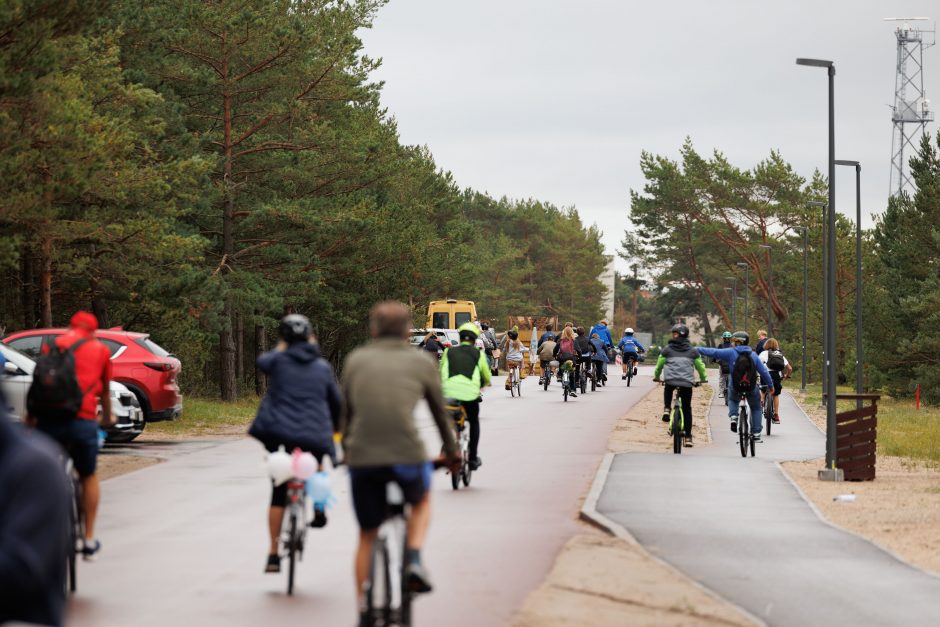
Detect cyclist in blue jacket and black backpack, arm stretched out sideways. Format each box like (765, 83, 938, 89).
(698, 331, 773, 442)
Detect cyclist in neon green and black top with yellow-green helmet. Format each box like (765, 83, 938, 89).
(441, 322, 490, 470)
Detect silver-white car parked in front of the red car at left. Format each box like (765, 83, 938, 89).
(0, 344, 145, 442)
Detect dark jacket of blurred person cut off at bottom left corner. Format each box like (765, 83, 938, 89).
(0, 394, 69, 625)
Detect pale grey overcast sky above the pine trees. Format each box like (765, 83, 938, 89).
(362, 0, 940, 269)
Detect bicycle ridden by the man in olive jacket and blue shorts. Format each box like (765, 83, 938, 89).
(360, 460, 443, 627)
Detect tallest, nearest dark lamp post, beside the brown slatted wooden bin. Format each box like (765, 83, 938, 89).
(796, 59, 842, 481)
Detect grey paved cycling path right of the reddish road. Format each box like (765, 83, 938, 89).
(597, 395, 940, 627)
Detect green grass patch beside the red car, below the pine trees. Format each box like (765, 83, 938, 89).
(144, 396, 259, 437)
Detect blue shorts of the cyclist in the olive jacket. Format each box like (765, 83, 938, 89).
(349, 462, 433, 530)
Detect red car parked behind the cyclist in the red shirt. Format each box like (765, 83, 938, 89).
(3, 328, 183, 422)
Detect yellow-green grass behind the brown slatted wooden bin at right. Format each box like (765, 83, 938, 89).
(788, 384, 940, 466)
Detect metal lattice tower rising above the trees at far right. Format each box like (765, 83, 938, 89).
(885, 17, 936, 196)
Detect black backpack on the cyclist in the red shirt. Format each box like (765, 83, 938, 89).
(26, 339, 86, 421)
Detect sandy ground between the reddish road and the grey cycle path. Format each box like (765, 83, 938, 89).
(514, 387, 752, 627)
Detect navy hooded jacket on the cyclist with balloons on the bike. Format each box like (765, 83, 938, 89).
(248, 342, 341, 454)
